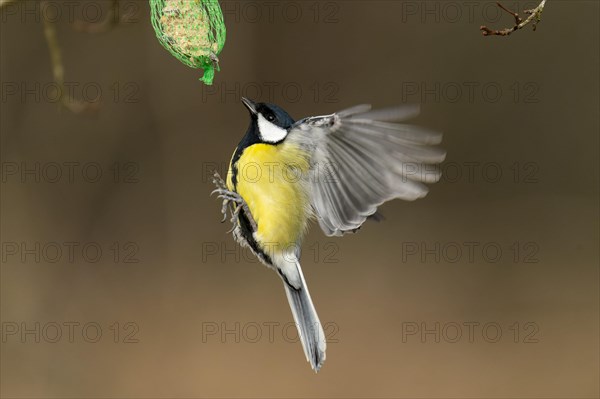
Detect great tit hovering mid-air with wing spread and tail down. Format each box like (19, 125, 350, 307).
(213, 98, 446, 372)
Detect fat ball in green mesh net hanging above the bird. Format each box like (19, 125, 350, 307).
(150, 0, 225, 85)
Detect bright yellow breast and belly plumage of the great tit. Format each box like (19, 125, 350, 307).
(227, 143, 310, 250)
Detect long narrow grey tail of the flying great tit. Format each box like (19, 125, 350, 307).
(283, 265, 327, 372)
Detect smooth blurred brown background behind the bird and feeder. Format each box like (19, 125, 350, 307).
(0, 0, 599, 398)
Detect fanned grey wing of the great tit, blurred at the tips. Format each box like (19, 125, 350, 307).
(287, 105, 446, 236)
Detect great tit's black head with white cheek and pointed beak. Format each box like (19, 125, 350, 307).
(242, 97, 294, 144)
